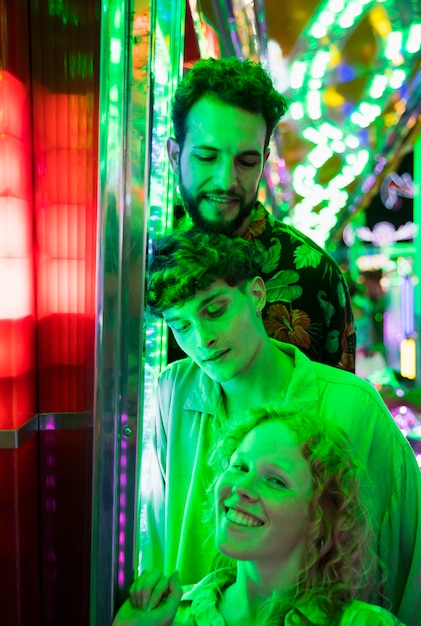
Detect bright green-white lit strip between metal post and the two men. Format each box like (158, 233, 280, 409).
(135, 0, 186, 570)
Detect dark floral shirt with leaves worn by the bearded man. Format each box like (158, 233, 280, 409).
(244, 202, 356, 372)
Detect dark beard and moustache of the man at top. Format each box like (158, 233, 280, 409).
(179, 176, 257, 237)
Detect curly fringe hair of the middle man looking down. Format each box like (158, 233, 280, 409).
(146, 230, 260, 317)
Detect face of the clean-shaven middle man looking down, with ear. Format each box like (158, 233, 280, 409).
(163, 277, 266, 383)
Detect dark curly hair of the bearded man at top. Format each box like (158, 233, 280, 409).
(172, 57, 288, 149)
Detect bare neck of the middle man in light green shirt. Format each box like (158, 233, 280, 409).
(221, 336, 294, 417)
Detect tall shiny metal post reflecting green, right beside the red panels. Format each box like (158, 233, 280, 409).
(90, 0, 152, 626)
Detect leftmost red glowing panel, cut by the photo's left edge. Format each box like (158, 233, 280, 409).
(0, 72, 36, 429)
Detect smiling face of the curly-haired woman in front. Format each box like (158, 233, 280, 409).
(215, 419, 312, 570)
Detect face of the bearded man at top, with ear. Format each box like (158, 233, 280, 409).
(167, 95, 269, 235)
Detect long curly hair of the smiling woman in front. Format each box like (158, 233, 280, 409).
(207, 409, 379, 624)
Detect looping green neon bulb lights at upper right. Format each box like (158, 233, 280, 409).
(284, 0, 421, 246)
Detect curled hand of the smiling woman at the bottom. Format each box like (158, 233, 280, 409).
(113, 569, 182, 626)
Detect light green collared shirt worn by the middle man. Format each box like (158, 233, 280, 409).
(141, 340, 421, 626)
